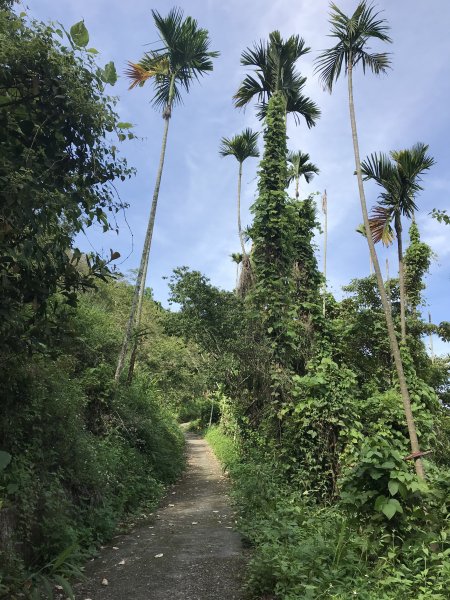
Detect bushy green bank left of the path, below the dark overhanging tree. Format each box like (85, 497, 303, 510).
(0, 276, 192, 593)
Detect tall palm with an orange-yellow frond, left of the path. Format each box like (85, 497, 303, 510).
(115, 8, 219, 381)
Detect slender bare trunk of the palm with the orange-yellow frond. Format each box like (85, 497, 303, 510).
(114, 76, 175, 382)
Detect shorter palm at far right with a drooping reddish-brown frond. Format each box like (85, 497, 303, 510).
(361, 143, 434, 342)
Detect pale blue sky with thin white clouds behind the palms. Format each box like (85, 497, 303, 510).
(26, 0, 450, 353)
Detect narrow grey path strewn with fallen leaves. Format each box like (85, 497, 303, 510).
(76, 433, 244, 600)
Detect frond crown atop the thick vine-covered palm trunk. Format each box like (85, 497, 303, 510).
(234, 31, 320, 127)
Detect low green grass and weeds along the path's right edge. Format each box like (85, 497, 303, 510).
(206, 427, 450, 600)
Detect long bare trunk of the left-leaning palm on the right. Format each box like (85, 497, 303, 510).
(348, 61, 425, 479)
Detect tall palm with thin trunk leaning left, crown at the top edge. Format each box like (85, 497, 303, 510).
(316, 0, 425, 478)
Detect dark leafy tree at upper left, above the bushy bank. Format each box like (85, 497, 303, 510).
(0, 11, 132, 352)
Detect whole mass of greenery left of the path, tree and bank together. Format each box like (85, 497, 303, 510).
(0, 10, 202, 598)
